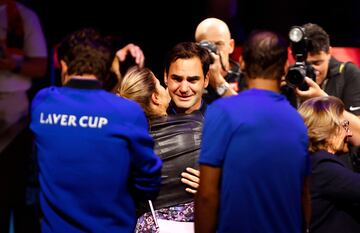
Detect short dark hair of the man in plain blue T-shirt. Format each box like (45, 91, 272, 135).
(243, 30, 288, 79)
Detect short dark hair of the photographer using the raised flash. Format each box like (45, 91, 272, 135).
(303, 23, 330, 54)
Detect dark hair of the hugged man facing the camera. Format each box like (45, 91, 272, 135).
(165, 42, 213, 76)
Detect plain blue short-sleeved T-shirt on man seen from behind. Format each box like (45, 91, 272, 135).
(199, 89, 310, 233)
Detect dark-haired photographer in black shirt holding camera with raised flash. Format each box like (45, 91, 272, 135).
(296, 23, 360, 171)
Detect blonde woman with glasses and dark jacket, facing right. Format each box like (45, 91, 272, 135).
(299, 96, 360, 233)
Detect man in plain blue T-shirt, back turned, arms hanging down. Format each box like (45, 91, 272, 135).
(195, 31, 310, 233)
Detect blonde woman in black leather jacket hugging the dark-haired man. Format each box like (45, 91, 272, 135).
(116, 67, 203, 232)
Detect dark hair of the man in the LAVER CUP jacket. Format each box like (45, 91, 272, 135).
(57, 28, 115, 81)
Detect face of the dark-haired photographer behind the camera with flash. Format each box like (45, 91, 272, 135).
(306, 51, 331, 85)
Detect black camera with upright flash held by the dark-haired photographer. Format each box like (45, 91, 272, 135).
(285, 26, 316, 91)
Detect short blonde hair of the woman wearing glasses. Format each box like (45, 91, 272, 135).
(298, 96, 344, 152)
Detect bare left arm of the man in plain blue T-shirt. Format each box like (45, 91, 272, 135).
(195, 165, 221, 233)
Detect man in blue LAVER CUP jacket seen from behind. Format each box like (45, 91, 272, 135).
(30, 29, 162, 233)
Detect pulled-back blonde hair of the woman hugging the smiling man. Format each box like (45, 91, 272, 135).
(116, 66, 156, 117)
